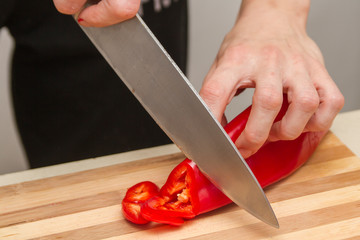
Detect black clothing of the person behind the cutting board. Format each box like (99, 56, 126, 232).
(0, 0, 187, 168)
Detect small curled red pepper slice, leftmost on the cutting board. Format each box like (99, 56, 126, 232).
(122, 181, 159, 224)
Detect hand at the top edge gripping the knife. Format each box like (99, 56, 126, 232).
(54, 0, 141, 27)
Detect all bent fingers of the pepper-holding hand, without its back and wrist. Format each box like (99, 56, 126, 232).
(200, 44, 344, 161)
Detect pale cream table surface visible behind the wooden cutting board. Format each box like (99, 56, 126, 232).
(0, 110, 360, 186)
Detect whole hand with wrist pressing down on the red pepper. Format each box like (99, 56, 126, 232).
(200, 0, 344, 158)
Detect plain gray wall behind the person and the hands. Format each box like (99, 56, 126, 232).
(0, 0, 360, 174)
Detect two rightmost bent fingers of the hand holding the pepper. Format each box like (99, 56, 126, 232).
(269, 62, 344, 141)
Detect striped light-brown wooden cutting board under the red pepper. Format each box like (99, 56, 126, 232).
(0, 133, 360, 240)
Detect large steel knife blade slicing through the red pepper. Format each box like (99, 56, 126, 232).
(74, 5, 279, 228)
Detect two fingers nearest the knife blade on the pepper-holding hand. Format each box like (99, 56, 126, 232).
(200, 48, 283, 157)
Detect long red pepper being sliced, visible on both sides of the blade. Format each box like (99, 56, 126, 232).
(123, 98, 325, 225)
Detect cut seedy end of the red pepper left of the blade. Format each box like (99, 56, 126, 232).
(141, 159, 231, 225)
